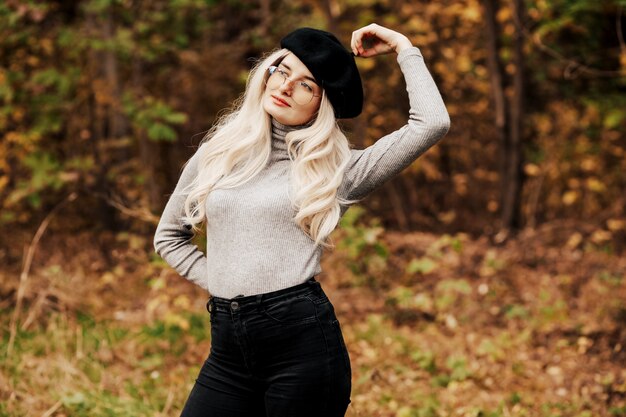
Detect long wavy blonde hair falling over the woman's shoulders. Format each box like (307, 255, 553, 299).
(182, 49, 358, 247)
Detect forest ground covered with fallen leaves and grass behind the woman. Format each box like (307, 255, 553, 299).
(0, 217, 626, 417)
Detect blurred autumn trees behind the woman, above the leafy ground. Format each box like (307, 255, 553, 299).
(0, 0, 626, 254)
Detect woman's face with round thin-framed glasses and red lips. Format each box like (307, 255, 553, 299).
(263, 53, 322, 126)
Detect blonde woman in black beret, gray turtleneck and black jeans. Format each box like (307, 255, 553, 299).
(154, 24, 450, 417)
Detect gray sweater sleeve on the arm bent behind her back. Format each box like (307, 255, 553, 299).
(153, 151, 208, 291)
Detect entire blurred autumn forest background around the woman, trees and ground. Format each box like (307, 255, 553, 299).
(0, 0, 626, 417)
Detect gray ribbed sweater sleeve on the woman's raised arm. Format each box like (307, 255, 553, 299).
(339, 46, 450, 200)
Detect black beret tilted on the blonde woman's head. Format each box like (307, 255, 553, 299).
(280, 28, 363, 119)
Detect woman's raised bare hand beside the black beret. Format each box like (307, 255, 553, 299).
(350, 23, 413, 58)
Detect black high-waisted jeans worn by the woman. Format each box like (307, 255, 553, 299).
(181, 277, 352, 417)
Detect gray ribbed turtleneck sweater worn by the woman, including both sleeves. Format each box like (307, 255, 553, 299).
(154, 47, 450, 298)
